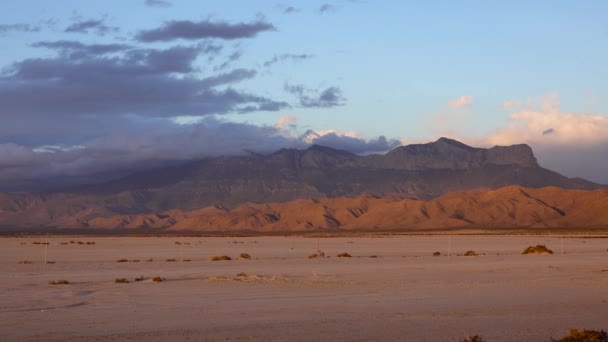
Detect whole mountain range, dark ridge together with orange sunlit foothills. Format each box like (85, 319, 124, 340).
(0, 138, 608, 230)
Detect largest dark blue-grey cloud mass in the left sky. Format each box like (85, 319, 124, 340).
(0, 41, 289, 145)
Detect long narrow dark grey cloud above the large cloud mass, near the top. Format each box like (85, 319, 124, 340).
(136, 19, 276, 42)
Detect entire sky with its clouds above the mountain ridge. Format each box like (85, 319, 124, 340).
(0, 0, 608, 191)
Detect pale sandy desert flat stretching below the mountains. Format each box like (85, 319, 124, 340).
(0, 235, 608, 341)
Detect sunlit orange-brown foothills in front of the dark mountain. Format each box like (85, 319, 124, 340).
(0, 186, 608, 232)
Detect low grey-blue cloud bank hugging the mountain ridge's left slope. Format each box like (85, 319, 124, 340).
(0, 116, 398, 191)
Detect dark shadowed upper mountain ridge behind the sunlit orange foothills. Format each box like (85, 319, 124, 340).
(0, 138, 600, 226)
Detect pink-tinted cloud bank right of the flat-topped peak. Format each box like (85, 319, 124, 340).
(483, 94, 608, 184)
